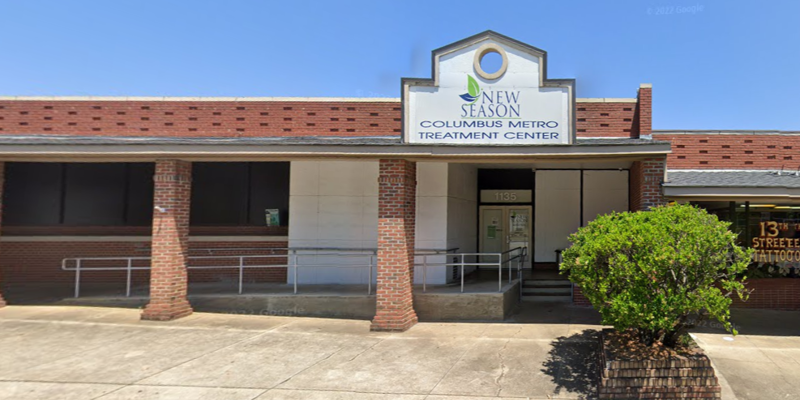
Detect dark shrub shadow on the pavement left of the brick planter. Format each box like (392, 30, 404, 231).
(542, 329, 600, 399)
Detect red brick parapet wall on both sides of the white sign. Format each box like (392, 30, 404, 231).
(0, 98, 636, 137)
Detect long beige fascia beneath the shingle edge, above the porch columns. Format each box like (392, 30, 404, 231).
(0, 141, 670, 162)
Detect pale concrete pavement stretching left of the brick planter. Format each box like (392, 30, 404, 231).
(0, 306, 598, 400)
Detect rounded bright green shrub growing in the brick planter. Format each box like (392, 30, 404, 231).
(561, 205, 752, 347)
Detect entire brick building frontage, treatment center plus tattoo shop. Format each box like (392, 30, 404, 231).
(0, 32, 800, 330)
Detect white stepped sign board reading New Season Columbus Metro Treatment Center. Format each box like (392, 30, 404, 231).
(403, 33, 574, 145)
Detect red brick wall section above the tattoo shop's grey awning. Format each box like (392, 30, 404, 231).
(653, 132, 800, 170)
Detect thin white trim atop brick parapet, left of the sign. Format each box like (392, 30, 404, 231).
(0, 96, 400, 103)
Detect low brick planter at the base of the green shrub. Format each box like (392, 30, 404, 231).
(598, 329, 722, 400)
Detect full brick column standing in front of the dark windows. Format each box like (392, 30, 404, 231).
(142, 160, 192, 321)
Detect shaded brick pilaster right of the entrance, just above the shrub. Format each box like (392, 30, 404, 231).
(629, 157, 667, 211)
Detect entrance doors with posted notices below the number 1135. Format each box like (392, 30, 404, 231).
(480, 206, 533, 265)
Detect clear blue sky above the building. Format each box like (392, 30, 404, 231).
(0, 0, 800, 130)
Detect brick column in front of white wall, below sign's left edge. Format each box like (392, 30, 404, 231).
(370, 160, 417, 332)
